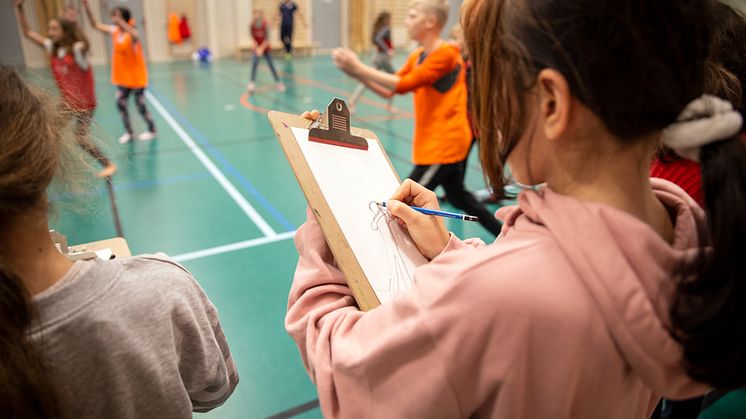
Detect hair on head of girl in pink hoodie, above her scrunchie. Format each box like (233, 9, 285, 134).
(463, 0, 710, 199)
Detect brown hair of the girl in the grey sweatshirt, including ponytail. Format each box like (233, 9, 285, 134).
(0, 66, 61, 418)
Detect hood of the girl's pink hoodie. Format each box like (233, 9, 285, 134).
(498, 179, 706, 399)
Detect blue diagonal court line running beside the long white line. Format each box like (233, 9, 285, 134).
(148, 87, 296, 231)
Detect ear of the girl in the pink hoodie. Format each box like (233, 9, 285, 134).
(537, 68, 573, 141)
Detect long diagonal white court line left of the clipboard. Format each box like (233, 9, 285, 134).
(145, 90, 277, 237)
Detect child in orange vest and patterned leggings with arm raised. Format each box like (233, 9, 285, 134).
(83, 0, 156, 144)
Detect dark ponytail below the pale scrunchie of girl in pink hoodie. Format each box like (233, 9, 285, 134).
(671, 133, 746, 389)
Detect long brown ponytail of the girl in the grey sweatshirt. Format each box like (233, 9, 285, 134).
(0, 263, 62, 418)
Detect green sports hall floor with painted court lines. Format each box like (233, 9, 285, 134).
(24, 55, 497, 418)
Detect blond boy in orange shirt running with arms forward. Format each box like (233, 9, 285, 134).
(332, 0, 502, 236)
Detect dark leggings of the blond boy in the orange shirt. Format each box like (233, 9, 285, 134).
(409, 162, 502, 236)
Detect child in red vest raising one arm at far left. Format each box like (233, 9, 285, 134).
(16, 0, 117, 177)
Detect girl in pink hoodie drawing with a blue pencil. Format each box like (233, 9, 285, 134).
(286, 0, 746, 418)
